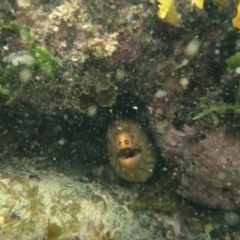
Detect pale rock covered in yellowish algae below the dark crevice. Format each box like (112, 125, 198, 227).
(0, 164, 160, 240)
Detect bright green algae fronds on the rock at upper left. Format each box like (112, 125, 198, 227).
(0, 21, 59, 105)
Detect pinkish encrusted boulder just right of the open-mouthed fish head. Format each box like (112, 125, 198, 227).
(149, 100, 240, 210)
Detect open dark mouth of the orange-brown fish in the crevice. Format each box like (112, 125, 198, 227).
(117, 148, 142, 169)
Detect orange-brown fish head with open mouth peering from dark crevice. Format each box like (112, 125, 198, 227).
(107, 121, 156, 182)
